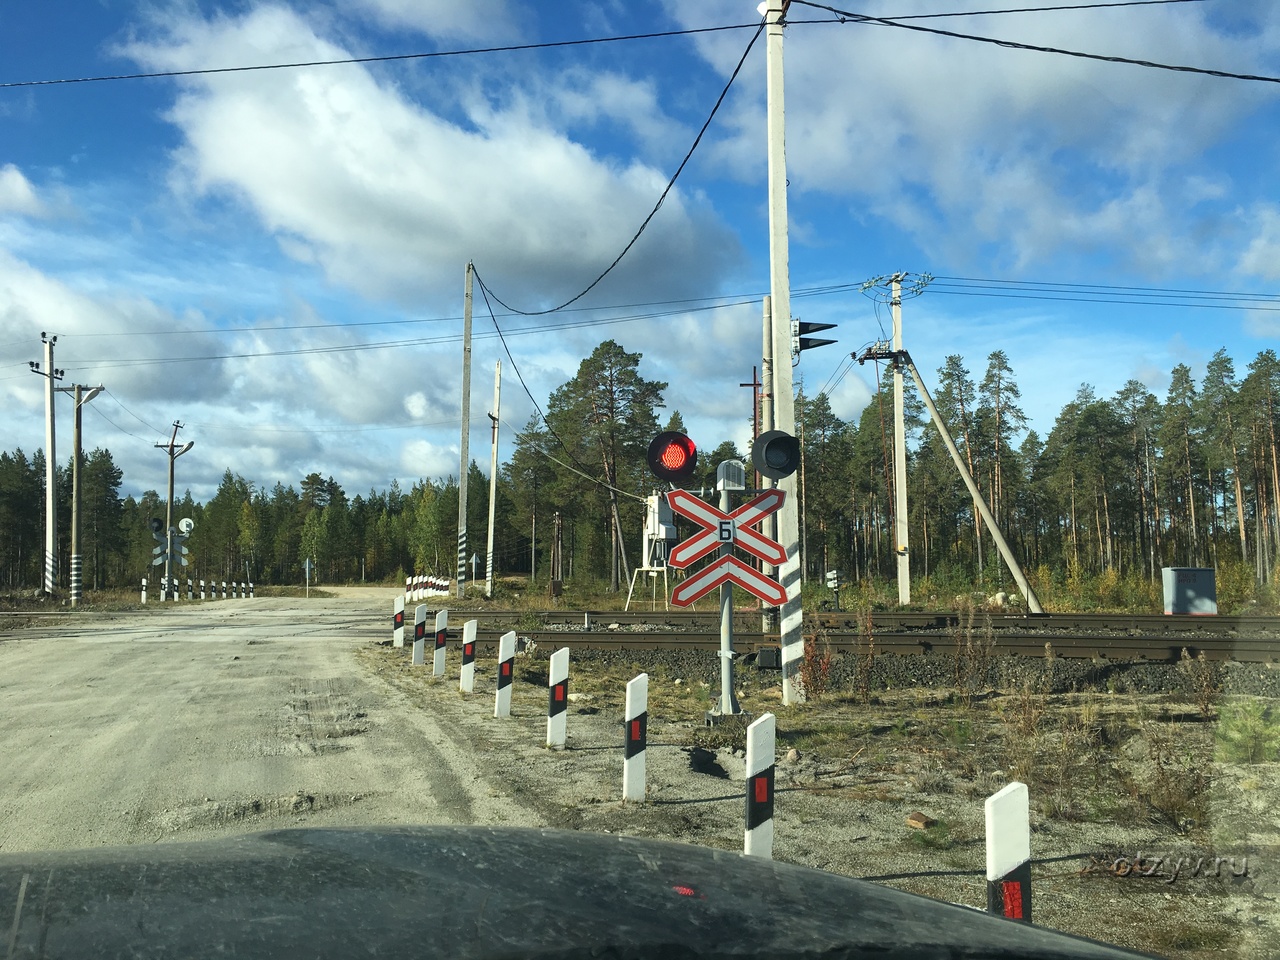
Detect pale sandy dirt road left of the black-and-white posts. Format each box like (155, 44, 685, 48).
(0, 591, 538, 851)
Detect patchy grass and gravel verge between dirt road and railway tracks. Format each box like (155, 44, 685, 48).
(360, 632, 1280, 957)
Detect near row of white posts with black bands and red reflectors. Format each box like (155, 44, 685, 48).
(392, 596, 1032, 923)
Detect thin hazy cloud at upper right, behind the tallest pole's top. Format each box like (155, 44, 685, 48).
(664, 0, 1280, 275)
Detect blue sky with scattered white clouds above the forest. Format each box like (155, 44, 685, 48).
(0, 0, 1280, 498)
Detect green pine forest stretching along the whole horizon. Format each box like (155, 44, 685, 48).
(0, 340, 1280, 607)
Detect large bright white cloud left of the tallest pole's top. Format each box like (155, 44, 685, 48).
(122, 8, 737, 312)
